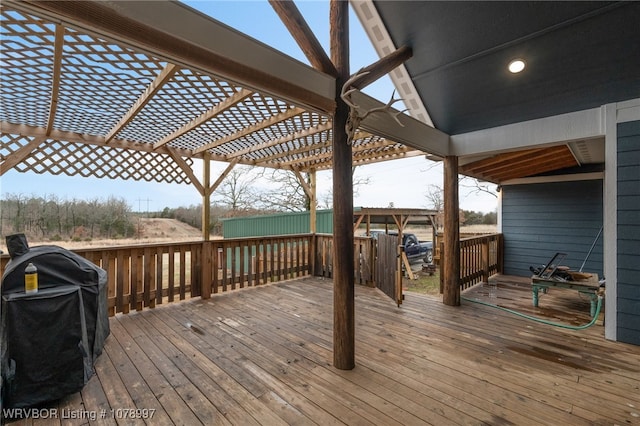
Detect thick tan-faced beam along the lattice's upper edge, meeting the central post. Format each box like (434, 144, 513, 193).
(11, 0, 335, 113)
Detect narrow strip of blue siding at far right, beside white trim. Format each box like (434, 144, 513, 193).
(607, 121, 640, 345)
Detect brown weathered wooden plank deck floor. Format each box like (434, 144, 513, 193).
(6, 278, 640, 425)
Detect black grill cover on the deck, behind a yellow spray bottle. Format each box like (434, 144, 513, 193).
(0, 246, 109, 408)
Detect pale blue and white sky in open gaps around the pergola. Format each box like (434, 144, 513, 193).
(0, 0, 497, 213)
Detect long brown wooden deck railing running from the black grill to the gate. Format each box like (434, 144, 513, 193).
(0, 234, 375, 316)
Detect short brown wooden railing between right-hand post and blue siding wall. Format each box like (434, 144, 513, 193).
(440, 234, 503, 290)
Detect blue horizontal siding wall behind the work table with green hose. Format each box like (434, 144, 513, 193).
(502, 180, 603, 276)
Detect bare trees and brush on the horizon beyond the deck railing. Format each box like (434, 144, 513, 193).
(0, 168, 497, 241)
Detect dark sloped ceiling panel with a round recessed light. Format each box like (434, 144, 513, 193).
(375, 1, 640, 134)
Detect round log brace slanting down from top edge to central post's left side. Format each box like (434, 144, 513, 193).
(269, 0, 338, 77)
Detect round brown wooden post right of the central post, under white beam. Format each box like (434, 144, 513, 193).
(441, 156, 460, 306)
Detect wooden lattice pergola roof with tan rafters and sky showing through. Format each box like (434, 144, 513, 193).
(0, 1, 430, 183)
